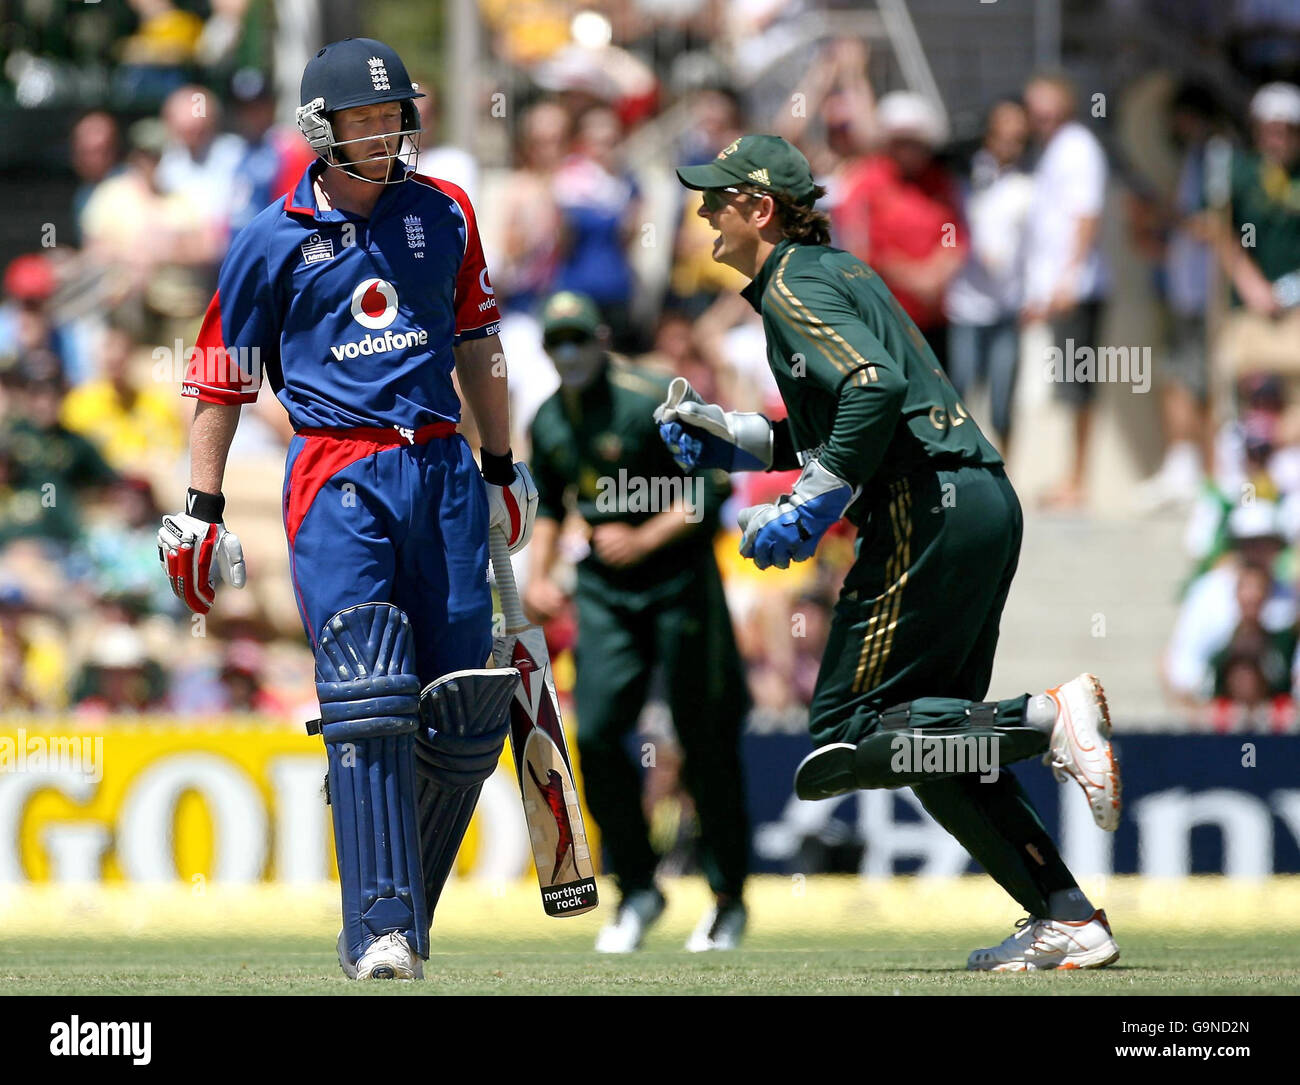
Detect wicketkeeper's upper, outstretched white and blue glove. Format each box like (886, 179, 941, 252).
(654, 377, 772, 470)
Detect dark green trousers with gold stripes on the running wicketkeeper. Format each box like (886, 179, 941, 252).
(809, 466, 1075, 916)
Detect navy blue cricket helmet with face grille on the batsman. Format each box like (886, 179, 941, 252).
(298, 38, 424, 185)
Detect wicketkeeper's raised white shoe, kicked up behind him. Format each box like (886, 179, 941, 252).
(1043, 674, 1121, 833)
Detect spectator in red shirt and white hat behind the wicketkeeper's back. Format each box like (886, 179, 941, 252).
(831, 91, 967, 368)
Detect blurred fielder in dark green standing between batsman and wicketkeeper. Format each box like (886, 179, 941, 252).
(524, 291, 749, 952)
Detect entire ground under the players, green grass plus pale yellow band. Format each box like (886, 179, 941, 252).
(0, 877, 1300, 997)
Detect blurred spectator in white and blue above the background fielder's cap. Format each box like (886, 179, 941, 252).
(554, 105, 640, 351)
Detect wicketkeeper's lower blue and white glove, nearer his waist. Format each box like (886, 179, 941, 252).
(738, 460, 862, 569)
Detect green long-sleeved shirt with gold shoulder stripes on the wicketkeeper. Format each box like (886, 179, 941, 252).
(741, 240, 1002, 522)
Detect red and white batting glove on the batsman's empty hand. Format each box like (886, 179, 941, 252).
(159, 490, 246, 615)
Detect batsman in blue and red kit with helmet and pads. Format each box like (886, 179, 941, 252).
(159, 38, 537, 980)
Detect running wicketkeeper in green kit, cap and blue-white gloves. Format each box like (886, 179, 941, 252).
(655, 135, 1119, 972)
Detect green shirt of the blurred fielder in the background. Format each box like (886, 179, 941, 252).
(529, 357, 731, 589)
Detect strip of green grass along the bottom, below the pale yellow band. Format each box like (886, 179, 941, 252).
(0, 933, 1300, 997)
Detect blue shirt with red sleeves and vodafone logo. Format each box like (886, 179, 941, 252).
(182, 160, 499, 430)
